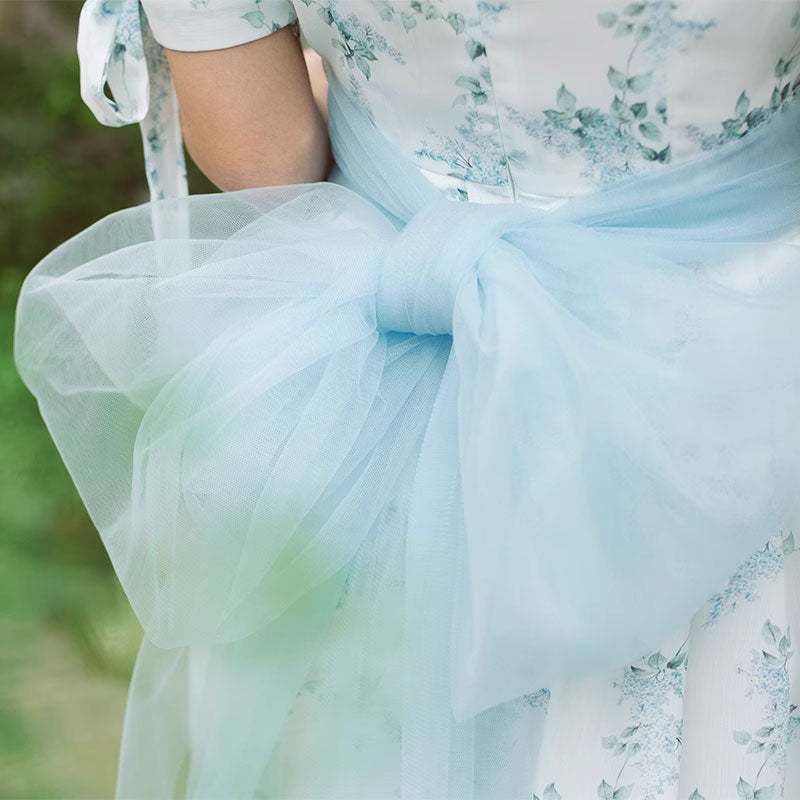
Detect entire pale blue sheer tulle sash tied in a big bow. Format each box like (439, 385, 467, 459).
(16, 73, 800, 798)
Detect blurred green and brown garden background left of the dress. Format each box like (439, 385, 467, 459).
(0, 0, 213, 800)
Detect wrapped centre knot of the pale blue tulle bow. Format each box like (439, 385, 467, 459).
(376, 198, 542, 335)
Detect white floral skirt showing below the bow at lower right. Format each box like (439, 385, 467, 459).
(534, 533, 800, 800)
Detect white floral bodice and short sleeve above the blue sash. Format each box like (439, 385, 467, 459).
(143, 0, 800, 208)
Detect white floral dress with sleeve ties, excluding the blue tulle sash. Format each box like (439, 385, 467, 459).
(79, 0, 800, 800)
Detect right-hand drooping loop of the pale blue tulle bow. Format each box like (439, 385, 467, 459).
(450, 223, 800, 718)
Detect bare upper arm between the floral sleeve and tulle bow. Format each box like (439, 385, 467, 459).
(166, 27, 331, 191)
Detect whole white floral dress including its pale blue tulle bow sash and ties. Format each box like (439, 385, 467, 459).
(16, 0, 800, 800)
